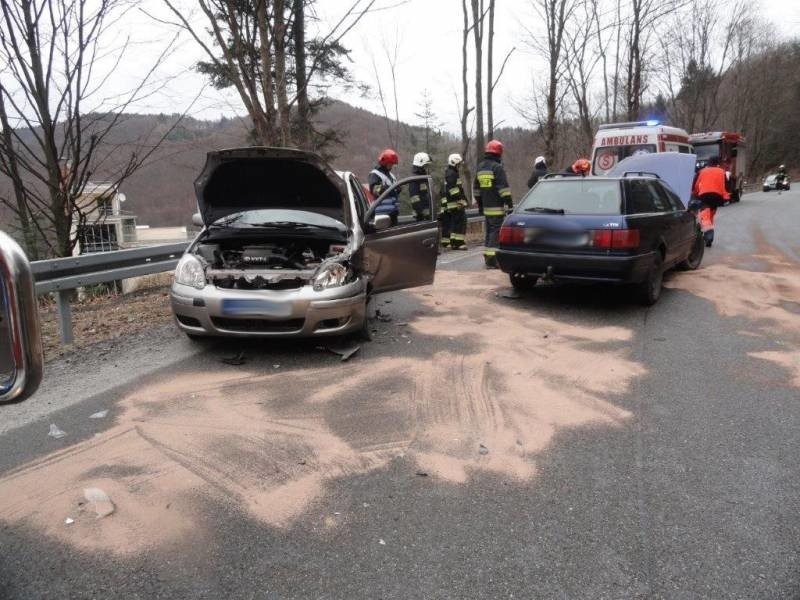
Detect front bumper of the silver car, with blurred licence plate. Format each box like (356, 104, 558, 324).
(170, 277, 367, 337)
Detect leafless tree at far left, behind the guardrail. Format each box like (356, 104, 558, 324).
(0, 0, 183, 258)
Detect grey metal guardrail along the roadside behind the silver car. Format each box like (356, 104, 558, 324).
(31, 209, 482, 344)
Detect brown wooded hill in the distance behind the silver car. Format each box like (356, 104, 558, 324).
(0, 101, 535, 227)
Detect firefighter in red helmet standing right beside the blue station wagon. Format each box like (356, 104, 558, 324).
(473, 140, 514, 269)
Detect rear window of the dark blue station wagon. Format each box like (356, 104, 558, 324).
(518, 177, 622, 215)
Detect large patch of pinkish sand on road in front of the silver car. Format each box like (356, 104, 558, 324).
(0, 271, 645, 554)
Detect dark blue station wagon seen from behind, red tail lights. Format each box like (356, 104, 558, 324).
(497, 173, 705, 305)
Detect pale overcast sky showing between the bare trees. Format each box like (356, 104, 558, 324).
(110, 0, 800, 131)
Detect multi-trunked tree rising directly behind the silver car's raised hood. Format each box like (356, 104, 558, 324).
(163, 0, 377, 145)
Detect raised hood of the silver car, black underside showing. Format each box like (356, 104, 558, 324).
(194, 146, 347, 225)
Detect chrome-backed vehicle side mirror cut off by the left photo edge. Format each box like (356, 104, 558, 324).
(0, 231, 44, 402)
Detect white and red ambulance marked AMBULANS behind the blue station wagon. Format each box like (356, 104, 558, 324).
(592, 121, 693, 175)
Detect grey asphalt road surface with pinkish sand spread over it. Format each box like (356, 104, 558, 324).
(0, 190, 800, 599)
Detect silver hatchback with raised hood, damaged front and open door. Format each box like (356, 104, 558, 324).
(171, 147, 439, 337)
